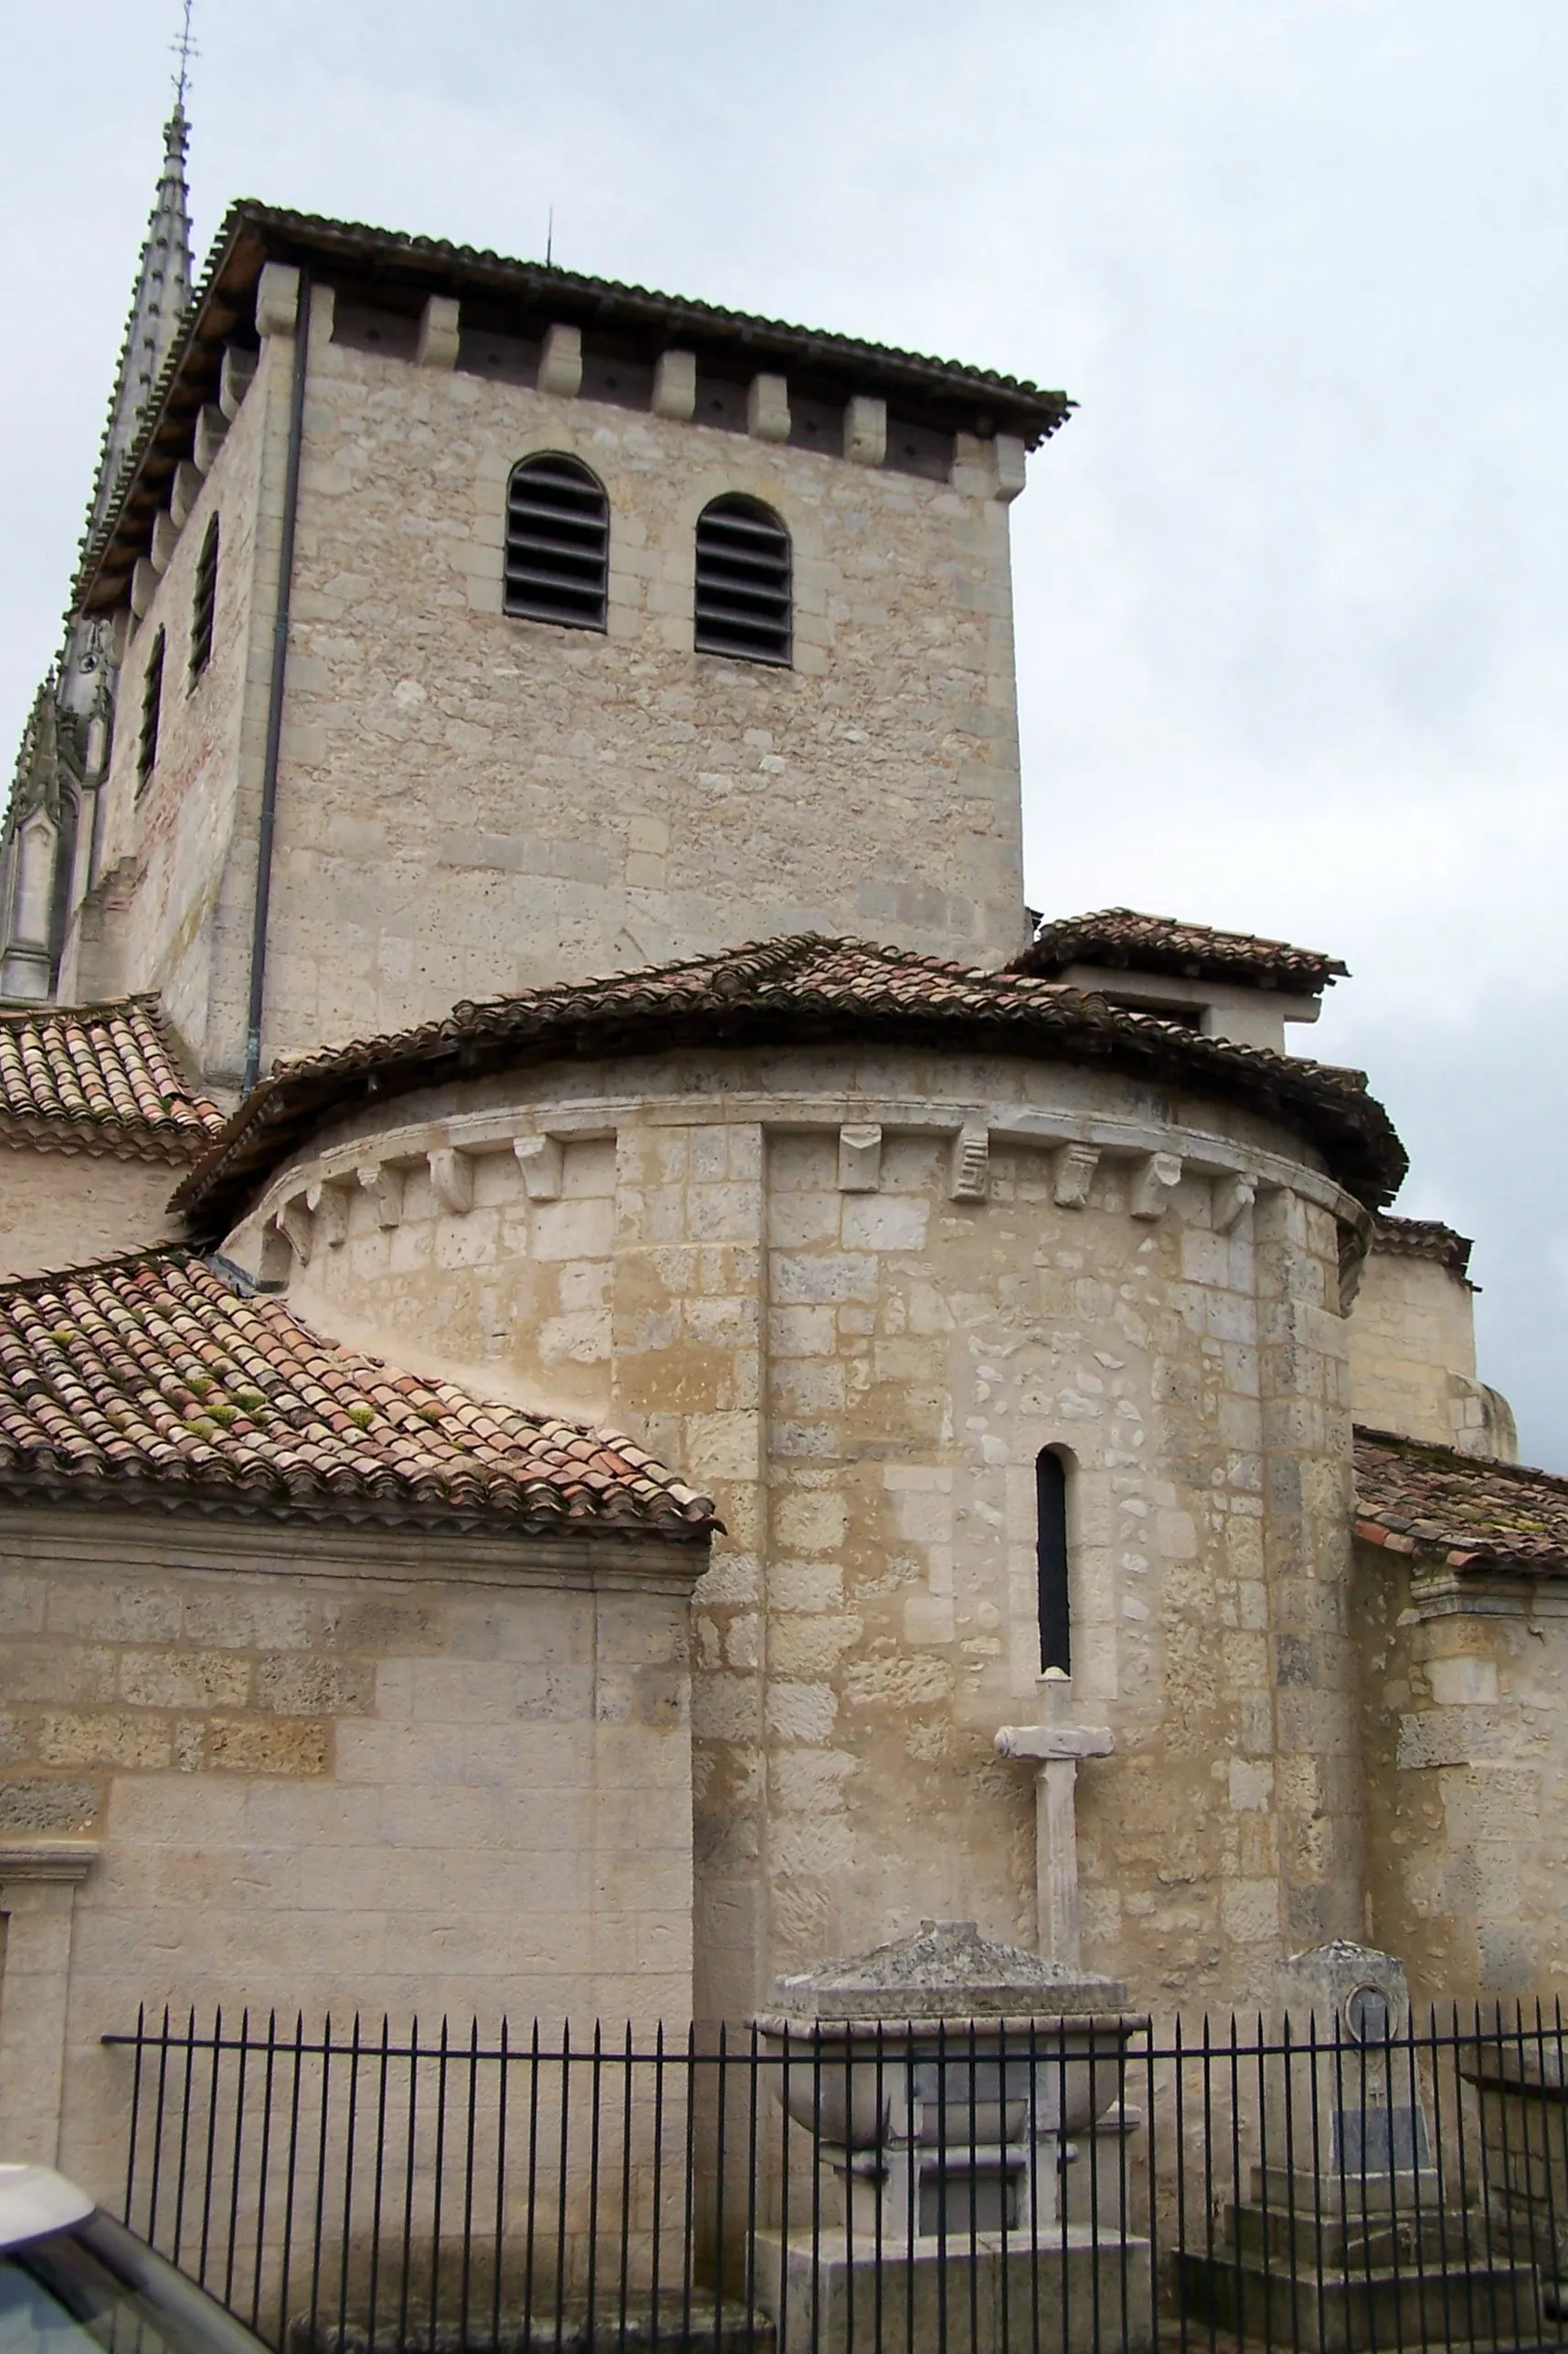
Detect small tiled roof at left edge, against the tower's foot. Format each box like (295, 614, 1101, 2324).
(0, 998, 224, 1161)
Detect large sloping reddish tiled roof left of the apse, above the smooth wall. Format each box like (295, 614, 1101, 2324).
(0, 1252, 715, 1540)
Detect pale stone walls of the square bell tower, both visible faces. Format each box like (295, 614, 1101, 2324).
(91, 273, 1024, 1083)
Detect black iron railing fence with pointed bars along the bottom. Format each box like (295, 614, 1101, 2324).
(106, 2012, 1568, 2354)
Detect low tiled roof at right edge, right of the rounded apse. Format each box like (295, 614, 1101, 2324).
(1356, 1431, 1568, 1577)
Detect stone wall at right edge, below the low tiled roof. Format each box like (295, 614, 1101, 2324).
(1356, 1544, 1568, 2003)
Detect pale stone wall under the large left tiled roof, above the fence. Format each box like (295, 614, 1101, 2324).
(0, 1511, 693, 2182)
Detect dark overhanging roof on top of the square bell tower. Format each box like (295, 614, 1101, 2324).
(75, 197, 1074, 612)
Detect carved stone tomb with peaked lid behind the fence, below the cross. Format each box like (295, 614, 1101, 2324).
(756, 1921, 1149, 2354)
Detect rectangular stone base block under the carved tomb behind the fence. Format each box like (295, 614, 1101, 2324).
(756, 2224, 1154, 2354)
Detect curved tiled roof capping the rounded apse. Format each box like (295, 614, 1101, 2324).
(175, 932, 1405, 1234)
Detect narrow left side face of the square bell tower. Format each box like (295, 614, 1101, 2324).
(61, 322, 281, 1095)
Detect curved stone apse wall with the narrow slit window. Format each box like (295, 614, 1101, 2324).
(226, 1050, 1363, 2015)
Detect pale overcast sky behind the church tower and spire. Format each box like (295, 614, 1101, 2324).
(0, 0, 1568, 1469)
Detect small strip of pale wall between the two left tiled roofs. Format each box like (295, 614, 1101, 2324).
(0, 1144, 181, 1278)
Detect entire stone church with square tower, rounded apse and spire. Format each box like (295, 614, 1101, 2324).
(0, 91, 1568, 2179)
